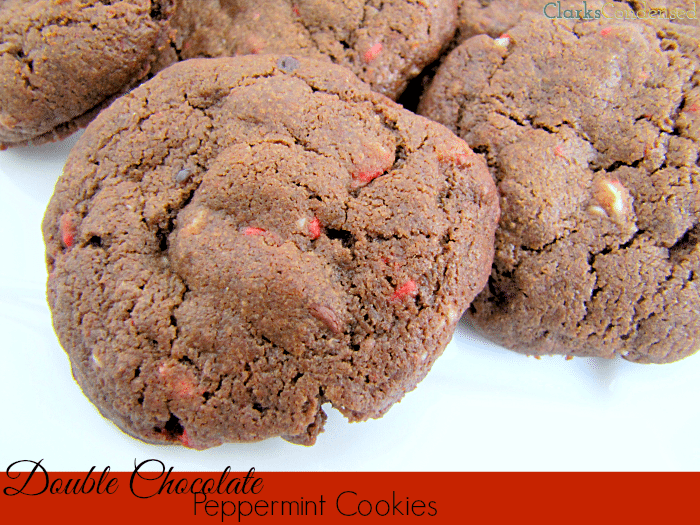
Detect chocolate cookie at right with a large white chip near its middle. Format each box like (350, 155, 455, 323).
(420, 20, 700, 363)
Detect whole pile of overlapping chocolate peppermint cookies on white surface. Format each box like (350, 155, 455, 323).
(0, 0, 700, 448)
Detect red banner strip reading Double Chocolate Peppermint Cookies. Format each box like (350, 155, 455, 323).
(0, 460, 700, 525)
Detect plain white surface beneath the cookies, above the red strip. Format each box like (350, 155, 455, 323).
(0, 132, 700, 470)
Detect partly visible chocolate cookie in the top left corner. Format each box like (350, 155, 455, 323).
(0, 0, 171, 148)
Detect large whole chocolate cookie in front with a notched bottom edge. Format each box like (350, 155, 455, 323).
(43, 55, 498, 448)
